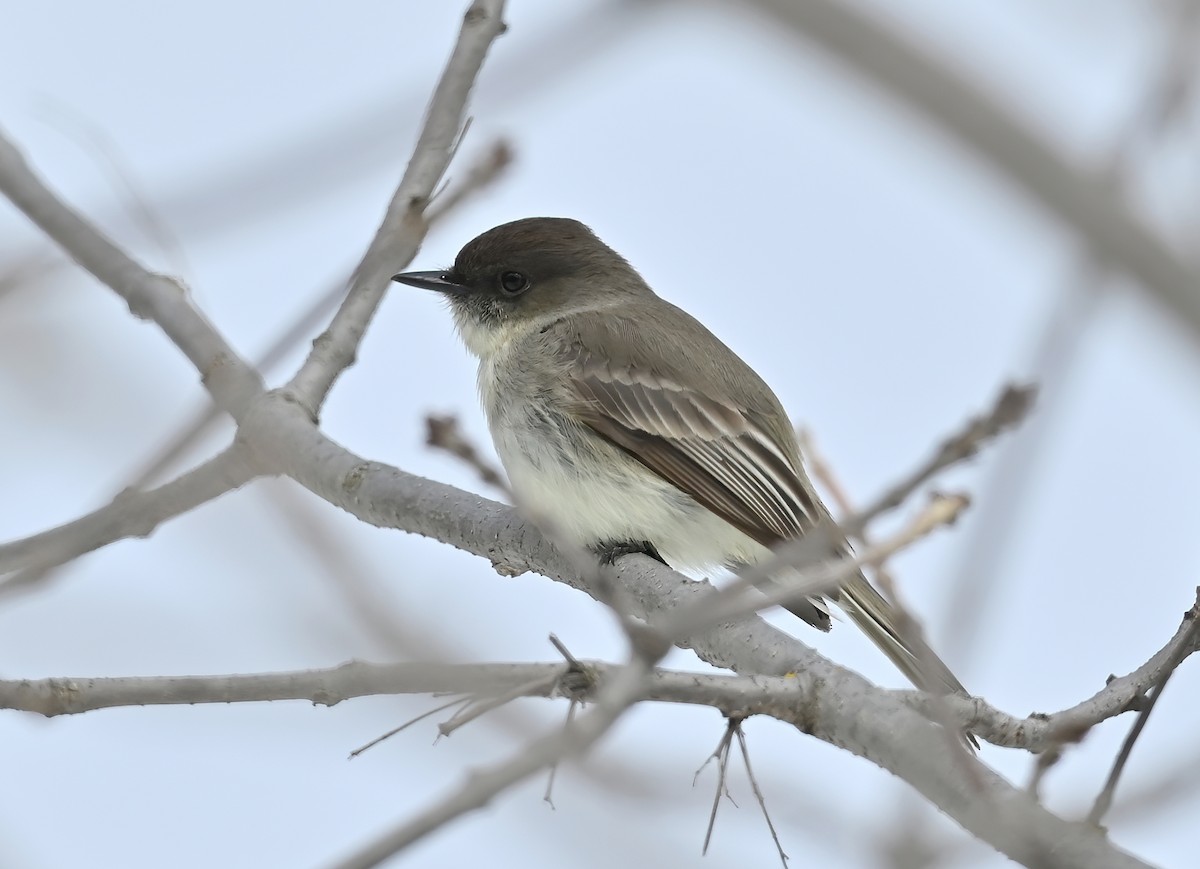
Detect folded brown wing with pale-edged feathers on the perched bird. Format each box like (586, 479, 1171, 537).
(570, 347, 823, 546)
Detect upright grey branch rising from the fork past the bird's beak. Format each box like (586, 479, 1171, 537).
(287, 0, 505, 416)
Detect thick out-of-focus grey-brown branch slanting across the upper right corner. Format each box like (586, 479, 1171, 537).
(727, 0, 1200, 343)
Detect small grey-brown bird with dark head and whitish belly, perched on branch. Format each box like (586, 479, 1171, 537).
(392, 217, 965, 694)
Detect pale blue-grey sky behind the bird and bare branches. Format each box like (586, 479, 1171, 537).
(0, 0, 1200, 869)
